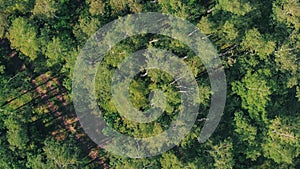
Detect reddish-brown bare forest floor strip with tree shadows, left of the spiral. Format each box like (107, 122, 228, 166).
(32, 73, 108, 169)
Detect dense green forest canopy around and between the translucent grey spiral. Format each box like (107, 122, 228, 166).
(0, 0, 300, 169)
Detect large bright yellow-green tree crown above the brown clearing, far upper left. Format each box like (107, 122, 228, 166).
(7, 17, 40, 60)
